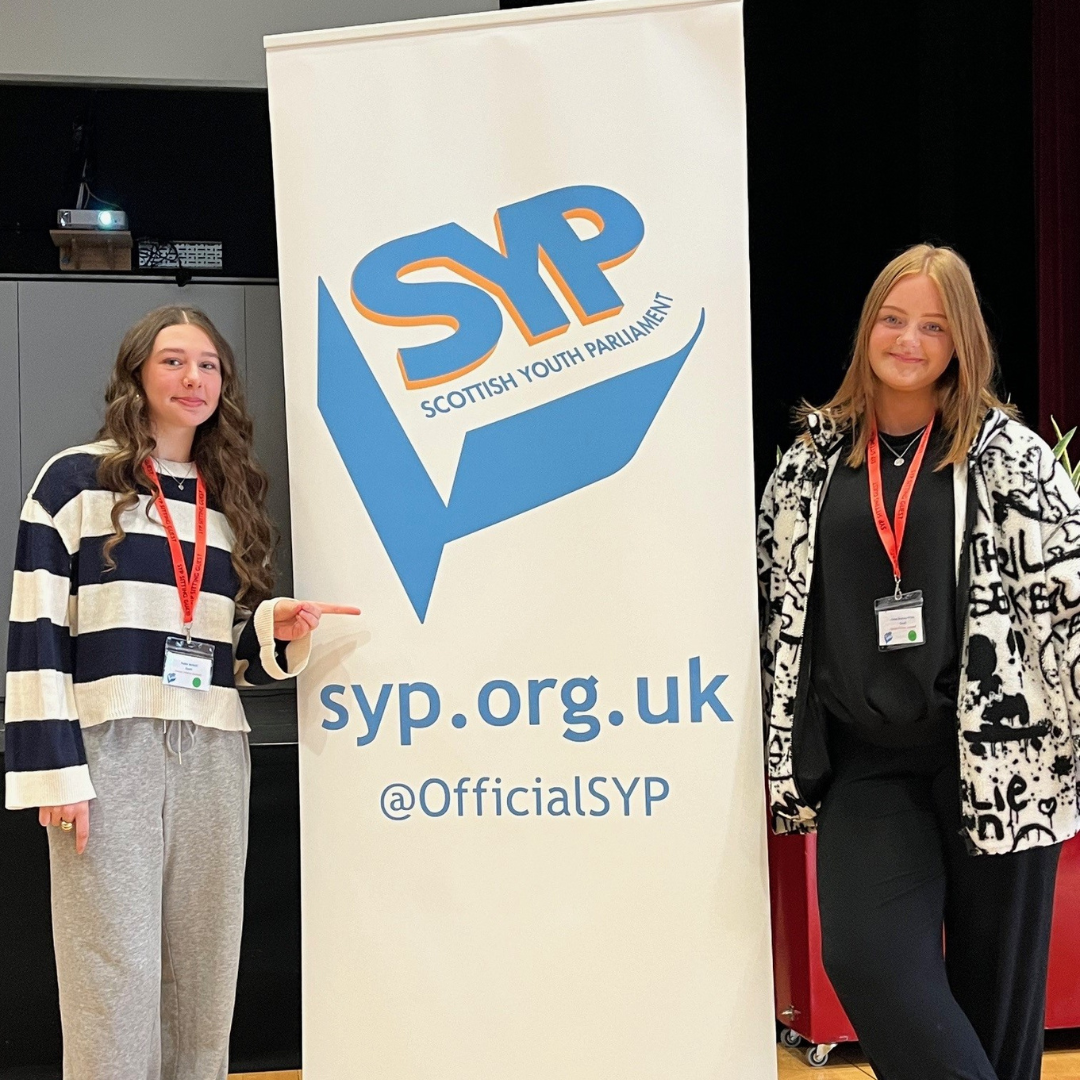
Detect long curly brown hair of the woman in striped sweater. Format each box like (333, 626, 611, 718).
(97, 306, 276, 610)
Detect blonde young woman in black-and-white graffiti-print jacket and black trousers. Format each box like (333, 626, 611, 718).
(758, 245, 1080, 1080)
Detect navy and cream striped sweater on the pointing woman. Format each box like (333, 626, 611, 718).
(4, 443, 311, 809)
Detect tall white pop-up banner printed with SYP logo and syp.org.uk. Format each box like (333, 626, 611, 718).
(267, 0, 775, 1080)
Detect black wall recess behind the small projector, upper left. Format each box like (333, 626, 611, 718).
(0, 84, 278, 278)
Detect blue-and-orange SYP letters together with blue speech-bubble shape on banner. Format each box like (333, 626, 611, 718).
(319, 185, 704, 621)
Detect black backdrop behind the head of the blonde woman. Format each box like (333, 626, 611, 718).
(744, 0, 1032, 489)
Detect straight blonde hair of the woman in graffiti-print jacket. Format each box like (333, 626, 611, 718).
(797, 244, 1017, 469)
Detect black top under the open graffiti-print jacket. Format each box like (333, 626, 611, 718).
(810, 422, 959, 747)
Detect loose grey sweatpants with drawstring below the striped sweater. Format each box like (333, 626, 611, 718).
(49, 718, 251, 1080)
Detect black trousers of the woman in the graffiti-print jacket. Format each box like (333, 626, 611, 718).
(818, 735, 1061, 1080)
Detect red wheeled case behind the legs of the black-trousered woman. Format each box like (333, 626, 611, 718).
(769, 834, 1080, 1066)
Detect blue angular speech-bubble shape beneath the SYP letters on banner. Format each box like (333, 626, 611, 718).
(319, 279, 705, 622)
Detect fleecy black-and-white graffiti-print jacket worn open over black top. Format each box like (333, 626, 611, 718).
(757, 409, 1080, 854)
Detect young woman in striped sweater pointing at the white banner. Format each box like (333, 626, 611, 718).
(5, 307, 359, 1080)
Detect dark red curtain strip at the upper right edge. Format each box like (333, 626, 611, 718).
(1035, 0, 1080, 440)
